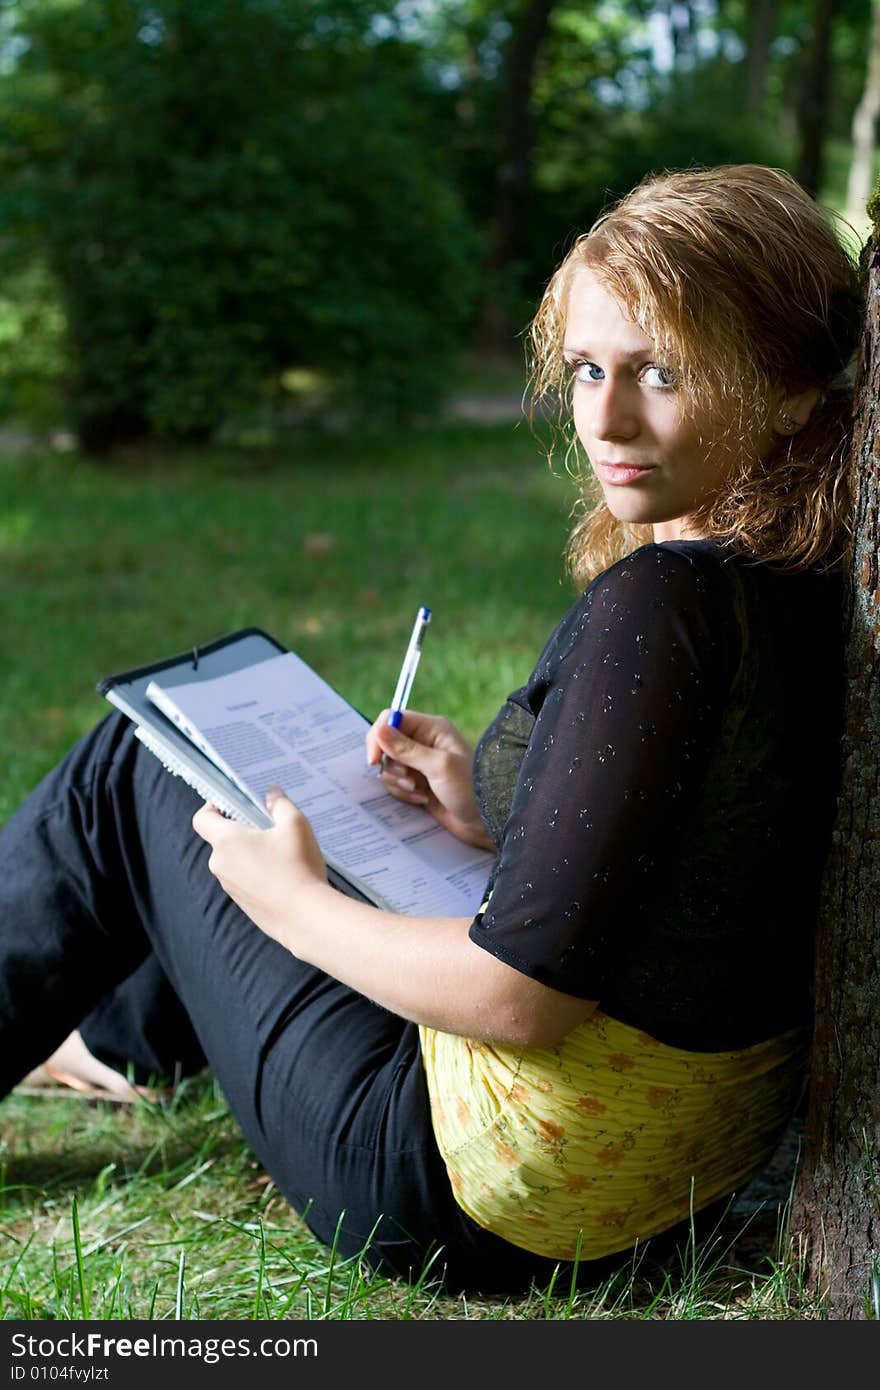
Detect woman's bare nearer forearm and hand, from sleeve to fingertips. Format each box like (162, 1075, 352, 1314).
(193, 792, 595, 1047)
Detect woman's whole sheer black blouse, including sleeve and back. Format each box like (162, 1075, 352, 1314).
(470, 541, 842, 1051)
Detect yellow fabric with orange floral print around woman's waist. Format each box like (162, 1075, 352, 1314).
(420, 1012, 806, 1259)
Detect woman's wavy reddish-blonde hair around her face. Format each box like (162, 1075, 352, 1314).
(530, 164, 863, 584)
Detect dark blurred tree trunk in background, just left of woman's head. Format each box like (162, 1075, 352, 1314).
(481, 0, 556, 353)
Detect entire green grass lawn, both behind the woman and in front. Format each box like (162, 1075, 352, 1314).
(0, 424, 820, 1319)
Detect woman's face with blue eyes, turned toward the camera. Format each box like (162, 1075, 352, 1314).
(564, 268, 774, 541)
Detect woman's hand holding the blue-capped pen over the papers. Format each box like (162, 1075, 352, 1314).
(367, 709, 495, 849)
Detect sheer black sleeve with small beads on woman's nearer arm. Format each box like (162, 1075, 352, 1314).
(470, 543, 738, 999)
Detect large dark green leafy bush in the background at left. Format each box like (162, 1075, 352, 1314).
(0, 0, 480, 449)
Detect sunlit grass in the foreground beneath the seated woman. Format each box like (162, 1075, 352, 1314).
(0, 1077, 820, 1321)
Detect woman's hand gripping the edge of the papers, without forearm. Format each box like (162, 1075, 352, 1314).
(192, 787, 327, 948)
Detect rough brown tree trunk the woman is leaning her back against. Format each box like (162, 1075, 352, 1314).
(792, 222, 880, 1319)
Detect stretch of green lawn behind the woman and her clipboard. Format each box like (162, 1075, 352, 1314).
(0, 411, 573, 820)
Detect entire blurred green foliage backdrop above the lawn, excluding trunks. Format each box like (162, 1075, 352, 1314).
(0, 0, 867, 446)
